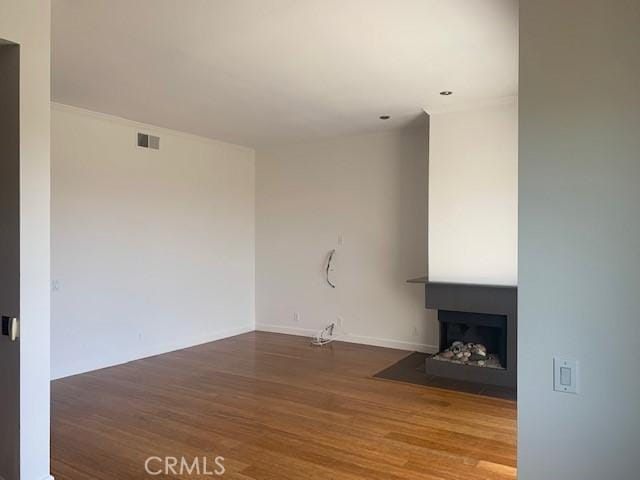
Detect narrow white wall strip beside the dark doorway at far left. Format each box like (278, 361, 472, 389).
(0, 0, 51, 480)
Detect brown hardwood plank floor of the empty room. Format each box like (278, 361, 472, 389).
(52, 332, 516, 480)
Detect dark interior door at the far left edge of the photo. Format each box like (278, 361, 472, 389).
(0, 39, 20, 480)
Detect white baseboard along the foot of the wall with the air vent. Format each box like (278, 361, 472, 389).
(51, 325, 255, 380)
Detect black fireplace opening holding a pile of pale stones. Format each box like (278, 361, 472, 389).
(432, 310, 507, 369)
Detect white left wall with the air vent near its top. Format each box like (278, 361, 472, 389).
(52, 105, 255, 378)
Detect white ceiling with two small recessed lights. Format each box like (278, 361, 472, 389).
(52, 0, 518, 146)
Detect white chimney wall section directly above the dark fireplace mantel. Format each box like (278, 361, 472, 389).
(429, 99, 518, 285)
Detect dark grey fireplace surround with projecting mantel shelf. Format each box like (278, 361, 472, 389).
(412, 279, 518, 389)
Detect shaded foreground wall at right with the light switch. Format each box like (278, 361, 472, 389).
(518, 0, 640, 480)
